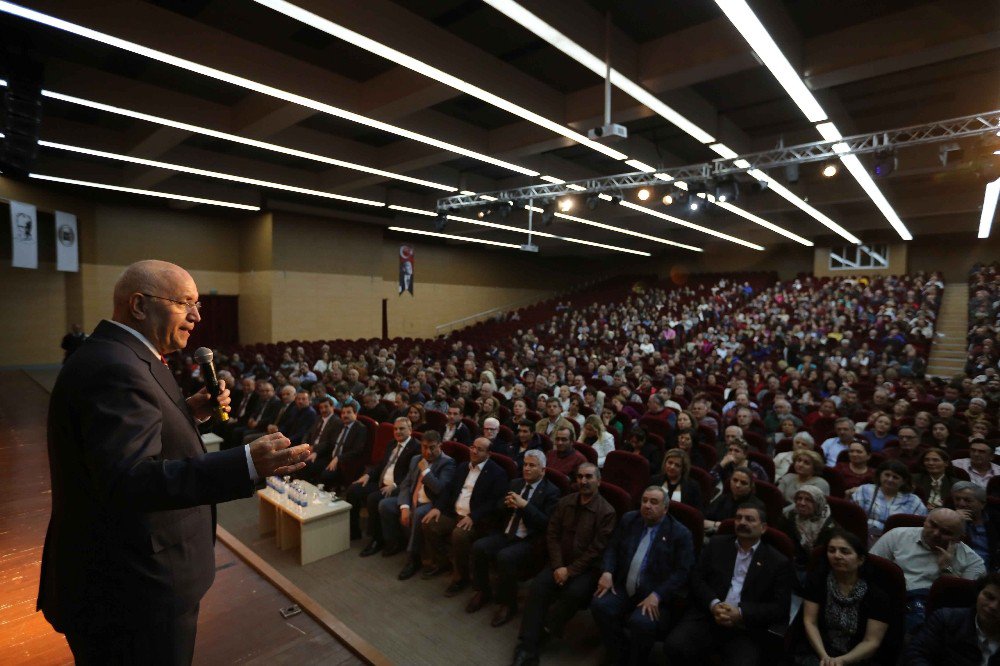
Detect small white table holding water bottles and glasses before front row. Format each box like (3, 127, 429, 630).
(257, 483, 351, 564)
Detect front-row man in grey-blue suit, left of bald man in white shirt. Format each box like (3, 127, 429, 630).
(378, 430, 455, 580)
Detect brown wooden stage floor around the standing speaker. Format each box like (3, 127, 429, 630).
(0, 371, 363, 666)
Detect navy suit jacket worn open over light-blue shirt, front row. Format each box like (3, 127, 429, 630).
(604, 511, 694, 603)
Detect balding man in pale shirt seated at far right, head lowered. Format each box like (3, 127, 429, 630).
(869, 509, 986, 633)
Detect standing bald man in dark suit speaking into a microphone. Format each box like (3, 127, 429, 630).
(38, 260, 310, 664)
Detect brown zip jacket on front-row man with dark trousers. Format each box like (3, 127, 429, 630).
(547, 493, 615, 576)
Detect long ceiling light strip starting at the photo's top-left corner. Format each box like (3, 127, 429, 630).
(0, 0, 539, 176)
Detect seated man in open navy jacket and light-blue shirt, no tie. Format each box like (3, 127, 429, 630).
(590, 486, 694, 666)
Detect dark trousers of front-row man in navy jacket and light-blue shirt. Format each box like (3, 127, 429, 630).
(590, 585, 669, 666)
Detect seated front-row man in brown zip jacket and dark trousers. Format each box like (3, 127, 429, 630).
(513, 463, 615, 666)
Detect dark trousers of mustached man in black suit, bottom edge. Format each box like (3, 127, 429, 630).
(663, 609, 764, 666)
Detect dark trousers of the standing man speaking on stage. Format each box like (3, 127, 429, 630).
(66, 606, 198, 666)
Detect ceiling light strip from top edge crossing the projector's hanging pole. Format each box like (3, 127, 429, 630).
(485, 0, 715, 143)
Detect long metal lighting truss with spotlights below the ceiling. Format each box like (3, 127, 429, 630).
(437, 109, 1000, 211)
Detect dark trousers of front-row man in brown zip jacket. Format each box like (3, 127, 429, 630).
(518, 567, 597, 654)
